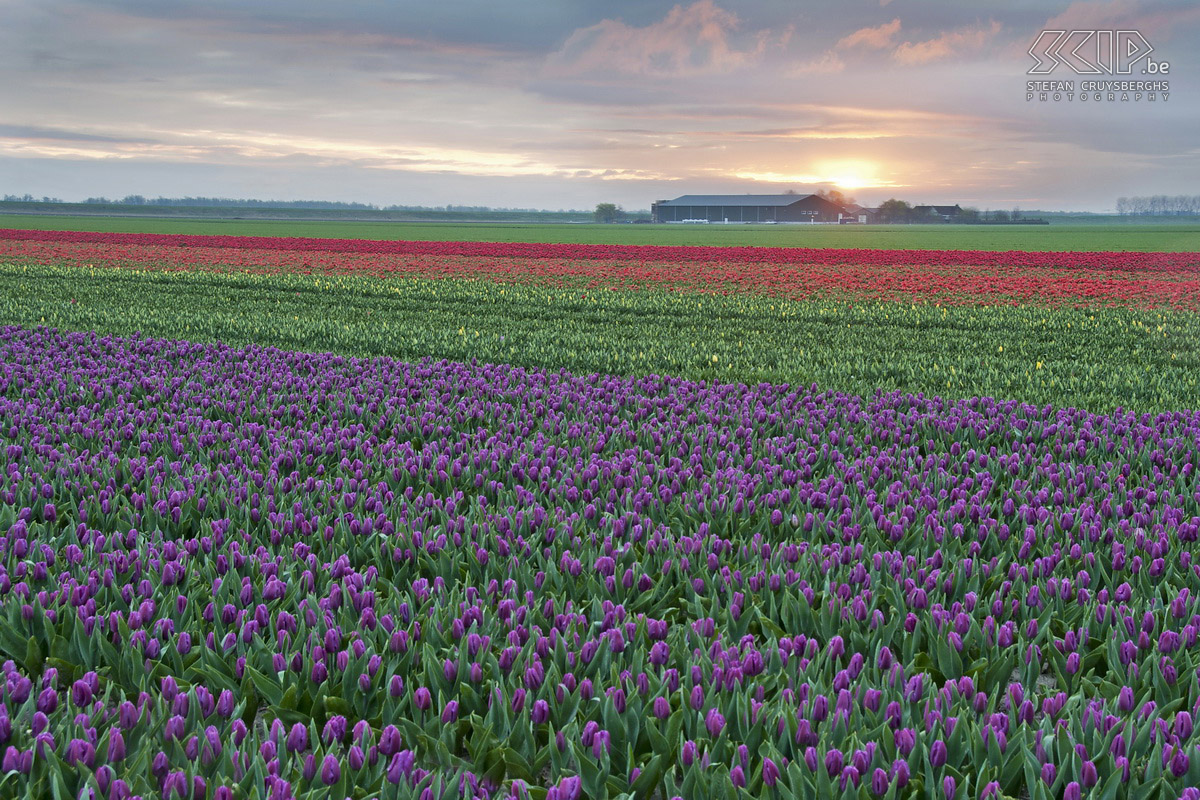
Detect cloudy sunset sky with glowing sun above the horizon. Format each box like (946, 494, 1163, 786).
(0, 0, 1200, 211)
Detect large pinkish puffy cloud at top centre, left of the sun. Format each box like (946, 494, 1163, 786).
(547, 0, 772, 76)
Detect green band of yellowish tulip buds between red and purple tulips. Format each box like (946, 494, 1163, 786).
(0, 265, 1200, 410)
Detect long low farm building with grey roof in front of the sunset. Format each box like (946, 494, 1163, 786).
(650, 194, 842, 222)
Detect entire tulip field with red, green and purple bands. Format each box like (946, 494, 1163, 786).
(0, 230, 1200, 800)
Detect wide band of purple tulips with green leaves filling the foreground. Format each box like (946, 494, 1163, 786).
(0, 327, 1200, 800)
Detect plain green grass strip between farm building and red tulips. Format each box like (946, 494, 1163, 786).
(0, 215, 1200, 252)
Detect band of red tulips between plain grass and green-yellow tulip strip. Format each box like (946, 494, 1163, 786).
(0, 230, 1200, 309)
